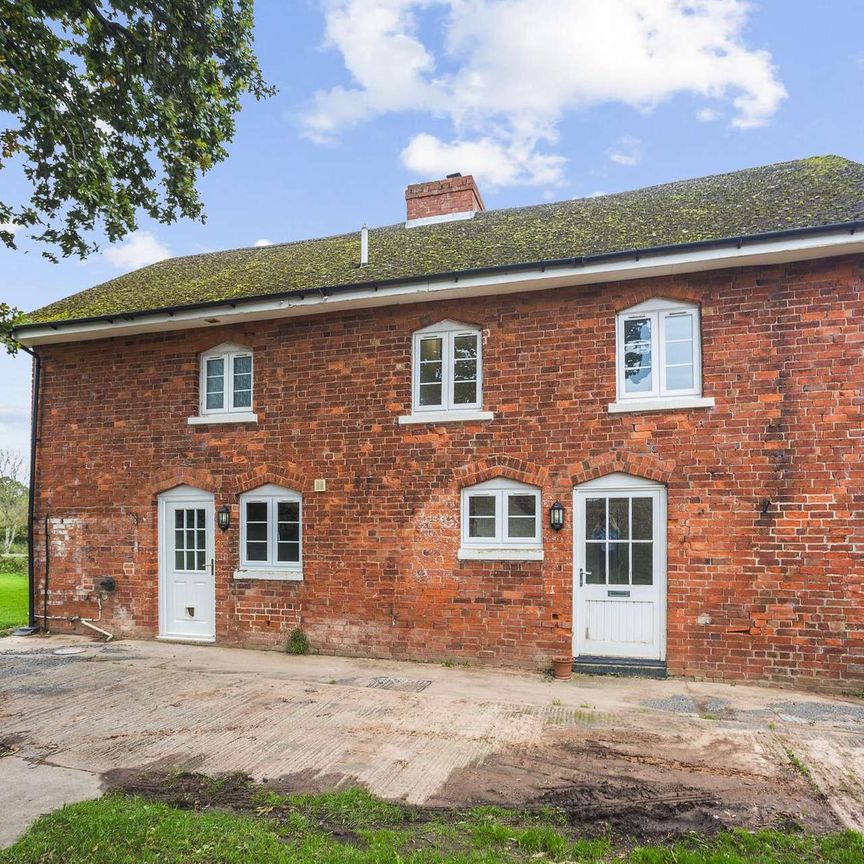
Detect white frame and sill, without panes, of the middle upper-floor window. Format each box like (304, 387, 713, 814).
(399, 320, 493, 423)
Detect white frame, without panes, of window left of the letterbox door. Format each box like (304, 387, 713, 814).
(457, 477, 543, 561)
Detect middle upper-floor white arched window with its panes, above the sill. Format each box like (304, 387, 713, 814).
(414, 321, 483, 412)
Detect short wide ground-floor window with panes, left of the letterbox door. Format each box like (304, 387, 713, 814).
(459, 477, 543, 560)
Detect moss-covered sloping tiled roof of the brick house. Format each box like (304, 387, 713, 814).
(23, 156, 864, 325)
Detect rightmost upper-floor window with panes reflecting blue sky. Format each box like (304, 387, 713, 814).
(610, 299, 713, 410)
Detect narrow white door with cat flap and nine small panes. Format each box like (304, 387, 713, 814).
(159, 486, 216, 642)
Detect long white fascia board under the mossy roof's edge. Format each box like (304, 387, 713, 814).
(16, 230, 864, 347)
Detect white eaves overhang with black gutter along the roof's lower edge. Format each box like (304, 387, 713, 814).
(13, 220, 864, 346)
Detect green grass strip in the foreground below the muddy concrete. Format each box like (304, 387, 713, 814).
(0, 780, 864, 864)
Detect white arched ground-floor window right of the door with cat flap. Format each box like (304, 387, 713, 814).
(235, 484, 303, 579)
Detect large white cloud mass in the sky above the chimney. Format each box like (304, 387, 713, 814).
(303, 0, 786, 185)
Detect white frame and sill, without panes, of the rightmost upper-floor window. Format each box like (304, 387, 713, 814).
(609, 298, 714, 413)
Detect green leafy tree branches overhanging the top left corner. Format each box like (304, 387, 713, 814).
(0, 0, 274, 260)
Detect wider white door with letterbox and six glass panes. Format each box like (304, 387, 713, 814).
(573, 474, 666, 660)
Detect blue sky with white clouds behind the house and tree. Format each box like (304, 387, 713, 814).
(0, 0, 864, 450)
